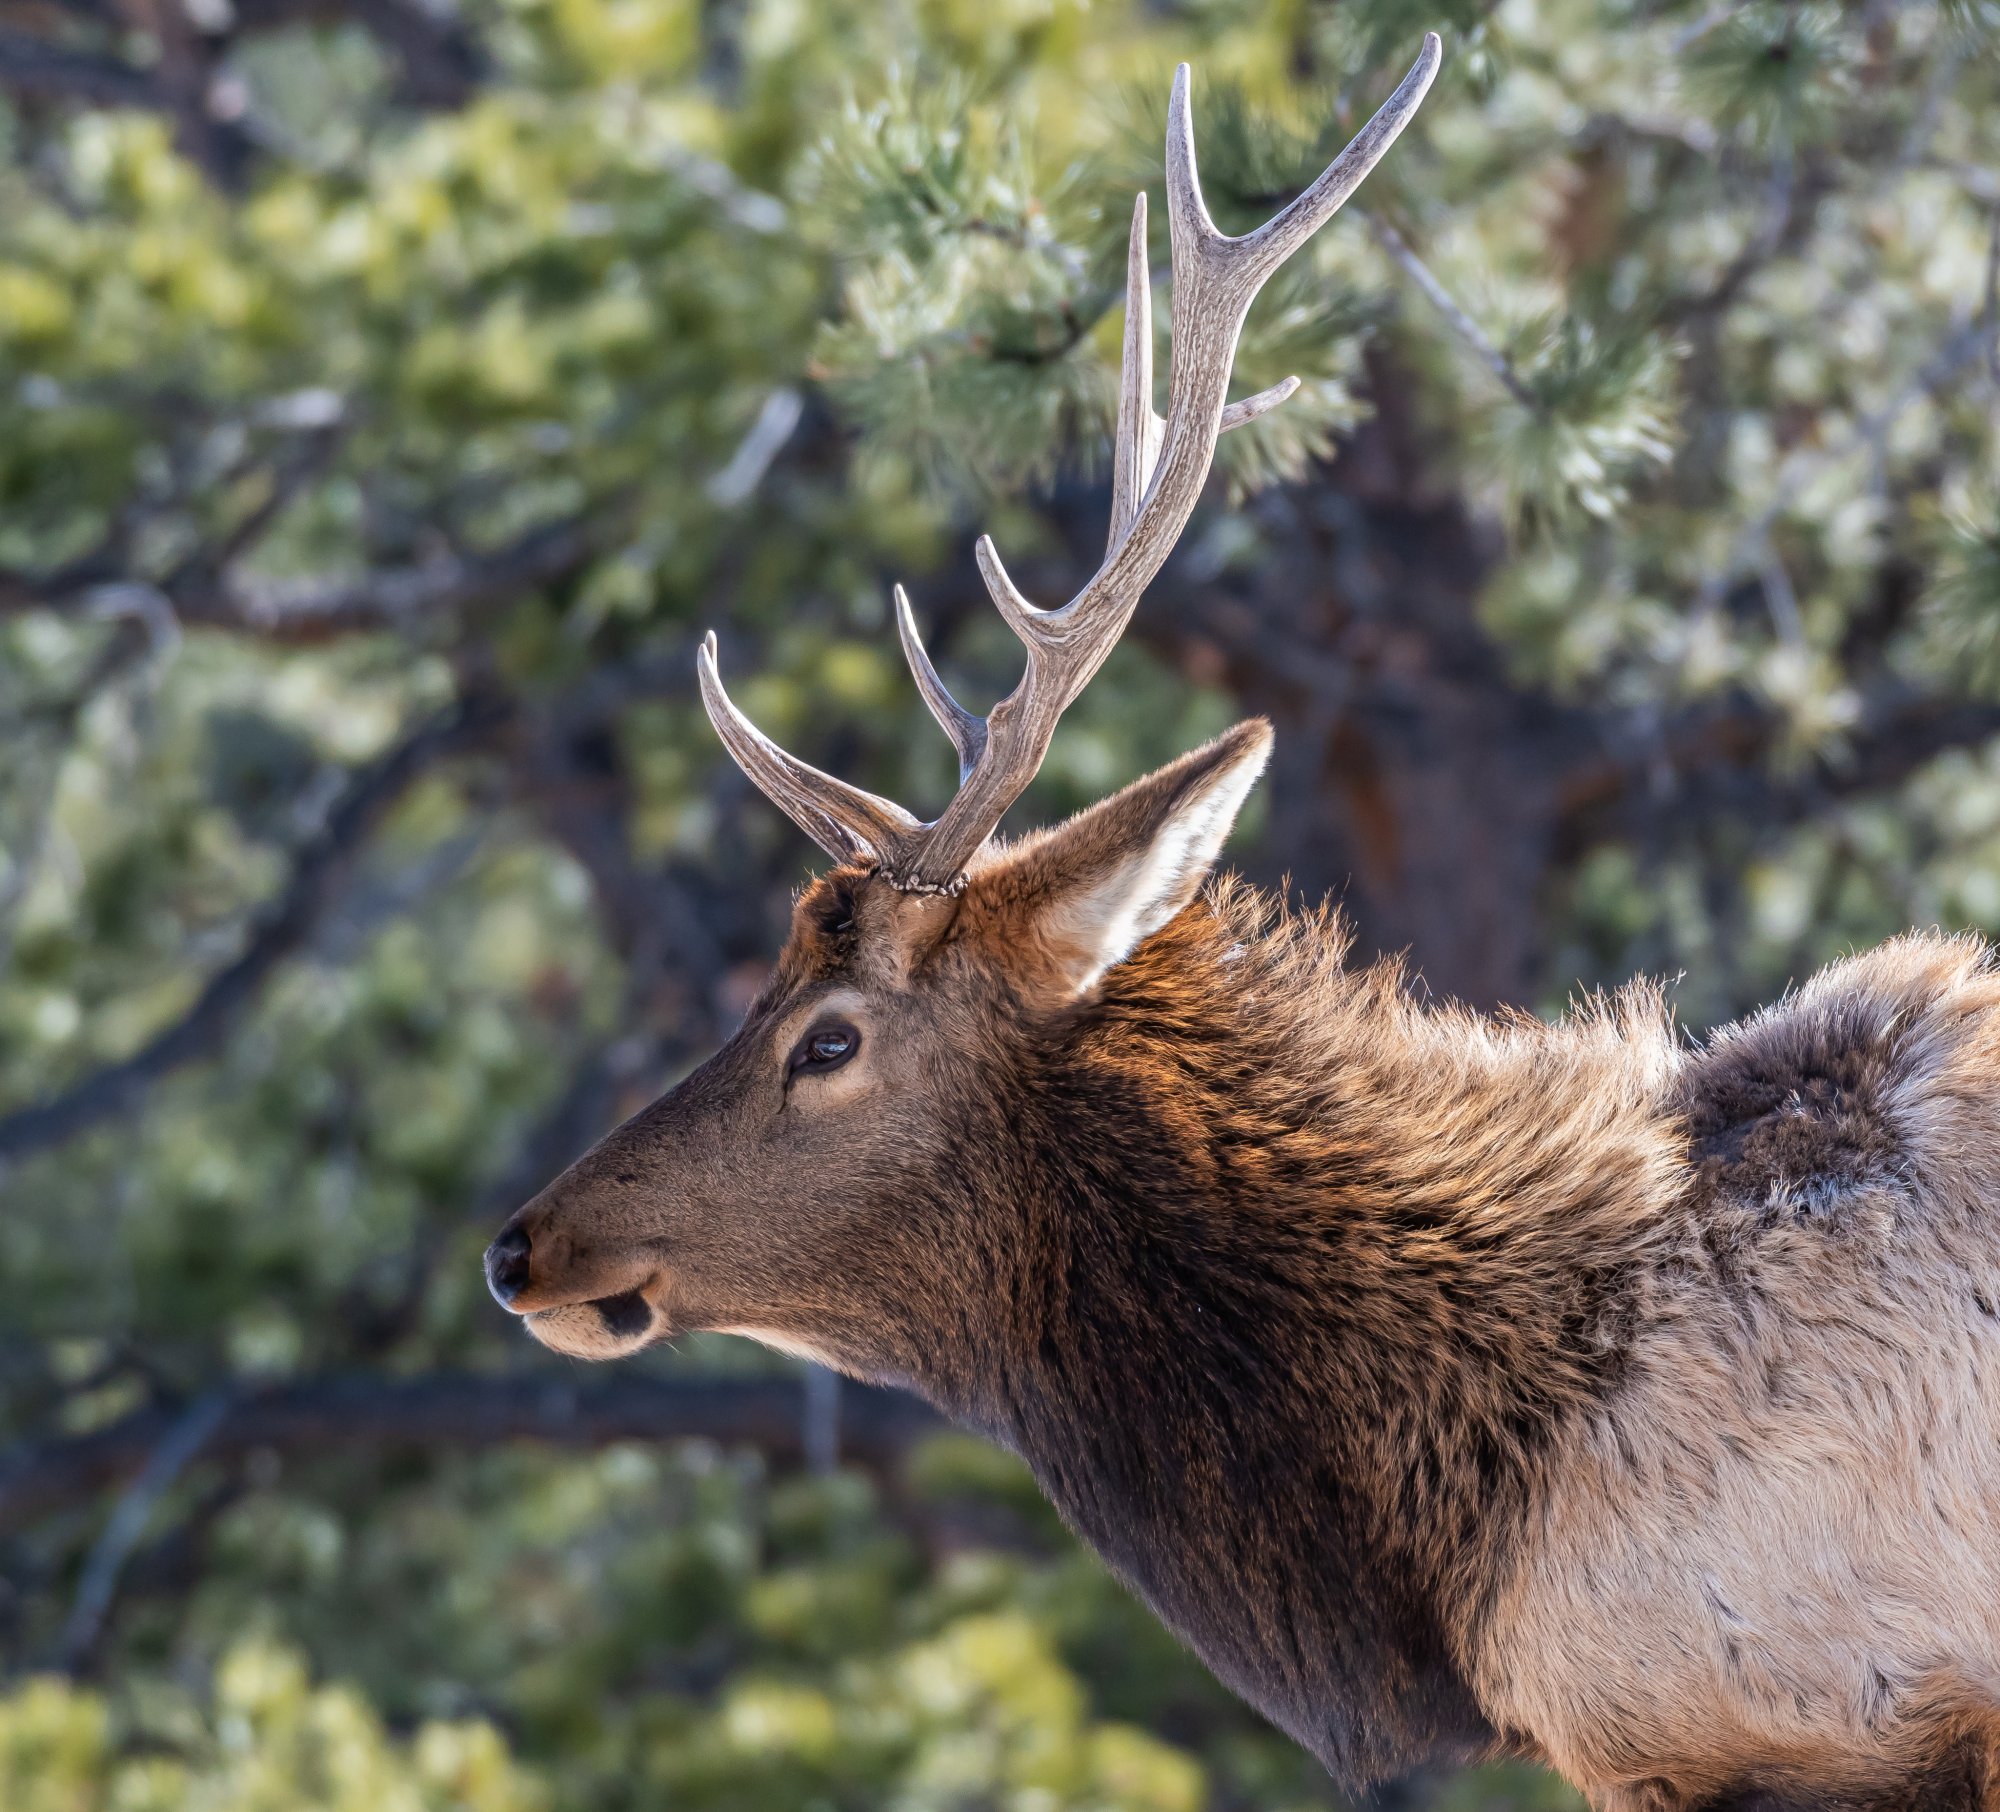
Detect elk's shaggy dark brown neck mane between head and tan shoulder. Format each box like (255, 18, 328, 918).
(884, 886, 1678, 1780)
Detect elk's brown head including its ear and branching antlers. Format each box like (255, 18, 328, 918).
(486, 49, 1440, 1396)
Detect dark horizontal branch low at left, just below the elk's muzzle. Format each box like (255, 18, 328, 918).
(0, 1374, 946, 1532)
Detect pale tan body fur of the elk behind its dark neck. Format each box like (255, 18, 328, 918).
(1468, 936, 2000, 1812)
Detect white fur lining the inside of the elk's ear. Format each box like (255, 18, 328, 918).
(1042, 742, 1270, 994)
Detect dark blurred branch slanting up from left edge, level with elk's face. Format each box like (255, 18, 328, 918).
(0, 704, 496, 1158)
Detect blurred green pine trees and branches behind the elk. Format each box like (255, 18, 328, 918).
(0, 0, 2000, 1812)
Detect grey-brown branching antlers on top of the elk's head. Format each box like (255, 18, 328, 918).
(700, 32, 1442, 894)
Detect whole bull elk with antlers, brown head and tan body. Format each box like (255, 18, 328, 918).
(486, 36, 2000, 1812)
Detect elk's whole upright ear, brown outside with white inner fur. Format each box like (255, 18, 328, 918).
(968, 718, 1270, 1000)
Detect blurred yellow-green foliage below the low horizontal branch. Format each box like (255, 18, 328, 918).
(0, 1438, 1568, 1812)
